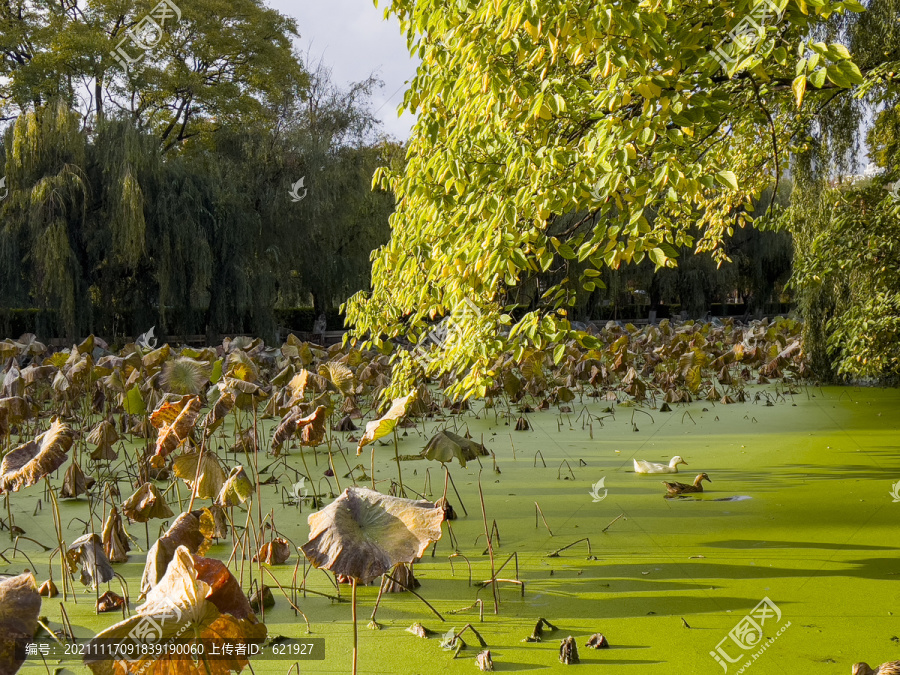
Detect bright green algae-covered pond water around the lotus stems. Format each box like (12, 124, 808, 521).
(7, 388, 900, 675)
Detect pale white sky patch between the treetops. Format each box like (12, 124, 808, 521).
(266, 0, 417, 140)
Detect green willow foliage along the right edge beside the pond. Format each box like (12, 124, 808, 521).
(781, 0, 900, 380)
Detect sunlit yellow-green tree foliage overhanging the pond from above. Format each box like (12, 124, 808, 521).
(347, 0, 887, 395)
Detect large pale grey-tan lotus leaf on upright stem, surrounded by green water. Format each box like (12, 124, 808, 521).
(301, 487, 444, 584)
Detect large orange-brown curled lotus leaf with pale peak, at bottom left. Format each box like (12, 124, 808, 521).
(85, 546, 266, 675)
